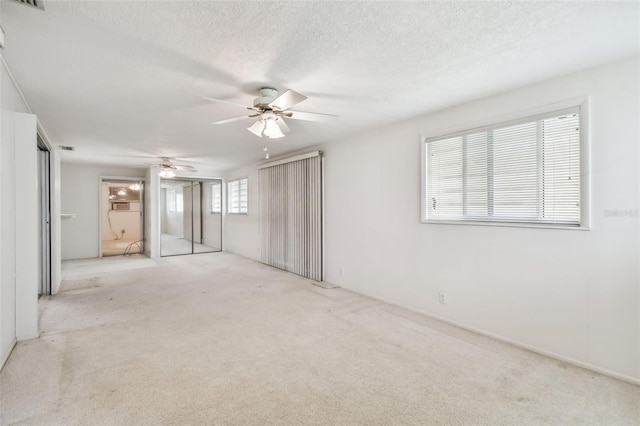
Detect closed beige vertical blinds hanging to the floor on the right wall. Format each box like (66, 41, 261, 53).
(259, 156, 322, 281)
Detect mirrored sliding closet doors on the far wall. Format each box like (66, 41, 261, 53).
(160, 178, 222, 257)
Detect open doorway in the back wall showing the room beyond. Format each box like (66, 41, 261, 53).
(100, 178, 144, 257)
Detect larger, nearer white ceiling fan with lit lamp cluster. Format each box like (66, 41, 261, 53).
(202, 87, 338, 140)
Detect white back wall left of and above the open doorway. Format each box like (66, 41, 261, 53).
(60, 163, 145, 260)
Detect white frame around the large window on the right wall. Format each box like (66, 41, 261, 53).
(420, 97, 591, 230)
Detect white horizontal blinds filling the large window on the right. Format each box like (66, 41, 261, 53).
(423, 107, 581, 226)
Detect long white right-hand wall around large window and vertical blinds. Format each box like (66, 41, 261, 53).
(225, 57, 640, 382)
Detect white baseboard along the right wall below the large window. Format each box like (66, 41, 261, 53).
(345, 288, 640, 386)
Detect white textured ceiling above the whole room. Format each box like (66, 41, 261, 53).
(0, 0, 640, 170)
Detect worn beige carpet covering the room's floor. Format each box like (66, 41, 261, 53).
(0, 253, 640, 425)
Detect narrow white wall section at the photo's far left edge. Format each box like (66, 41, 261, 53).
(0, 58, 38, 368)
